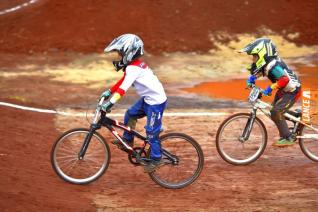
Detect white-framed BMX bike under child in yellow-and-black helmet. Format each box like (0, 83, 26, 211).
(216, 86, 318, 165)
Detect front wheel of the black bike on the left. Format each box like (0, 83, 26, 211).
(51, 128, 110, 184)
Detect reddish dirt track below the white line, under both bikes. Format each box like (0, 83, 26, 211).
(0, 107, 318, 211)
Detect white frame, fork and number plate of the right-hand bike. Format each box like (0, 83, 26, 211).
(240, 86, 318, 142)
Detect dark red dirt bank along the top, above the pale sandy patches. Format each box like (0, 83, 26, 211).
(0, 0, 318, 54)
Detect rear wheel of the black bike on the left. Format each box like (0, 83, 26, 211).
(147, 133, 204, 189)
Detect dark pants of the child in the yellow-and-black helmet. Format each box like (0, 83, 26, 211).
(271, 88, 300, 138)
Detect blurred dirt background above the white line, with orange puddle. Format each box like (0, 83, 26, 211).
(0, 0, 318, 107)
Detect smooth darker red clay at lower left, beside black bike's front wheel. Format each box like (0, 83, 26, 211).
(0, 107, 94, 211)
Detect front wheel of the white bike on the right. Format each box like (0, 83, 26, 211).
(216, 113, 267, 165)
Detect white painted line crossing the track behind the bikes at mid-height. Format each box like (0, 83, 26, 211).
(0, 102, 230, 117)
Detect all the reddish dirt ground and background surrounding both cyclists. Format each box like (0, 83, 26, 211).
(0, 0, 318, 211)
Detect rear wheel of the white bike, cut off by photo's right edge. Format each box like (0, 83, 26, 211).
(299, 125, 318, 162)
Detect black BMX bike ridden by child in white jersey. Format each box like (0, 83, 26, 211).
(51, 98, 204, 189)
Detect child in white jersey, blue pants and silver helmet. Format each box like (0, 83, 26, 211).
(102, 34, 167, 172)
